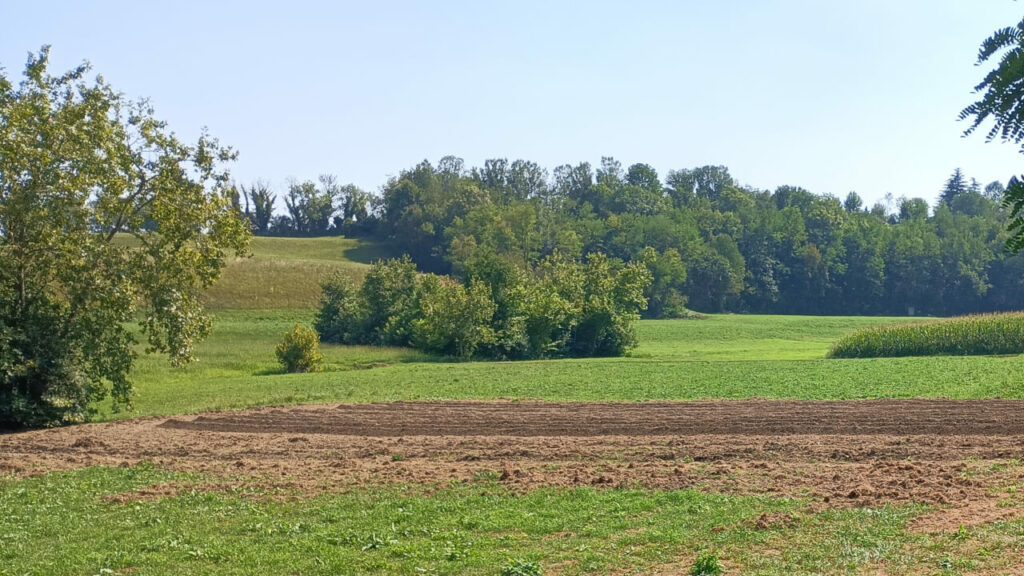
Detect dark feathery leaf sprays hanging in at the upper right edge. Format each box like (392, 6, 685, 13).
(961, 19, 1024, 252)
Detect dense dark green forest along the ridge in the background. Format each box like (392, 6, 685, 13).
(237, 157, 1024, 318)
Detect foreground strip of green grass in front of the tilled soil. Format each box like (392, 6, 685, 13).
(0, 465, 1024, 576)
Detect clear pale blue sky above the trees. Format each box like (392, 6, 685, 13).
(0, 0, 1024, 206)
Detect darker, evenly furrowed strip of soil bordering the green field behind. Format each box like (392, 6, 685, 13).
(163, 400, 1024, 437)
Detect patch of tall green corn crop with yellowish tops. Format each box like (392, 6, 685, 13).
(828, 313, 1024, 358)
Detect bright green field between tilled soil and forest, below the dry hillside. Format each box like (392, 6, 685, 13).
(99, 310, 1024, 419)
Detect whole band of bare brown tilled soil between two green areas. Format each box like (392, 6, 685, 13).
(0, 400, 1024, 531)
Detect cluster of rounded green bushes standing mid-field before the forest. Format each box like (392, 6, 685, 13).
(315, 253, 651, 360)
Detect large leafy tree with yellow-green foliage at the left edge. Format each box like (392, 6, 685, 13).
(0, 47, 249, 425)
